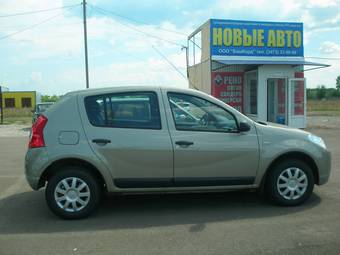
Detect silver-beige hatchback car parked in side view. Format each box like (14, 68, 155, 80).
(25, 87, 331, 219)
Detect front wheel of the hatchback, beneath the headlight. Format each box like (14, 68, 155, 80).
(265, 159, 315, 206)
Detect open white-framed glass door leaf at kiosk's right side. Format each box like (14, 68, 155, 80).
(288, 78, 306, 128)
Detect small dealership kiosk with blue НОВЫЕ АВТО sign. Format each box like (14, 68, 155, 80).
(187, 19, 328, 128)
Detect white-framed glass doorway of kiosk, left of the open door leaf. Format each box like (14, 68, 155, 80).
(267, 78, 288, 125)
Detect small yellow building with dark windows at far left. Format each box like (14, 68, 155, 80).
(2, 91, 40, 108)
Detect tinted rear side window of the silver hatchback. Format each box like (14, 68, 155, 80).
(85, 92, 161, 129)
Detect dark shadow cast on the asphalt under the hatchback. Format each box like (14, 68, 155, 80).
(0, 191, 321, 234)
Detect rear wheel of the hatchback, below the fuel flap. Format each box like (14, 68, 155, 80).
(45, 166, 102, 219)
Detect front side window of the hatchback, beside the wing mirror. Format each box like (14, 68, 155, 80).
(168, 93, 238, 132)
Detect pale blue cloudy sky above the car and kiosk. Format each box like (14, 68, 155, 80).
(0, 0, 340, 95)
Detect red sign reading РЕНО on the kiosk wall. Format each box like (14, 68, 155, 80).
(211, 72, 243, 112)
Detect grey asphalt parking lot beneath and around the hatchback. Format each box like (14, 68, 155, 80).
(0, 128, 340, 255)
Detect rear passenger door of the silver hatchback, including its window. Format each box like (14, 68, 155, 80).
(80, 90, 173, 188)
